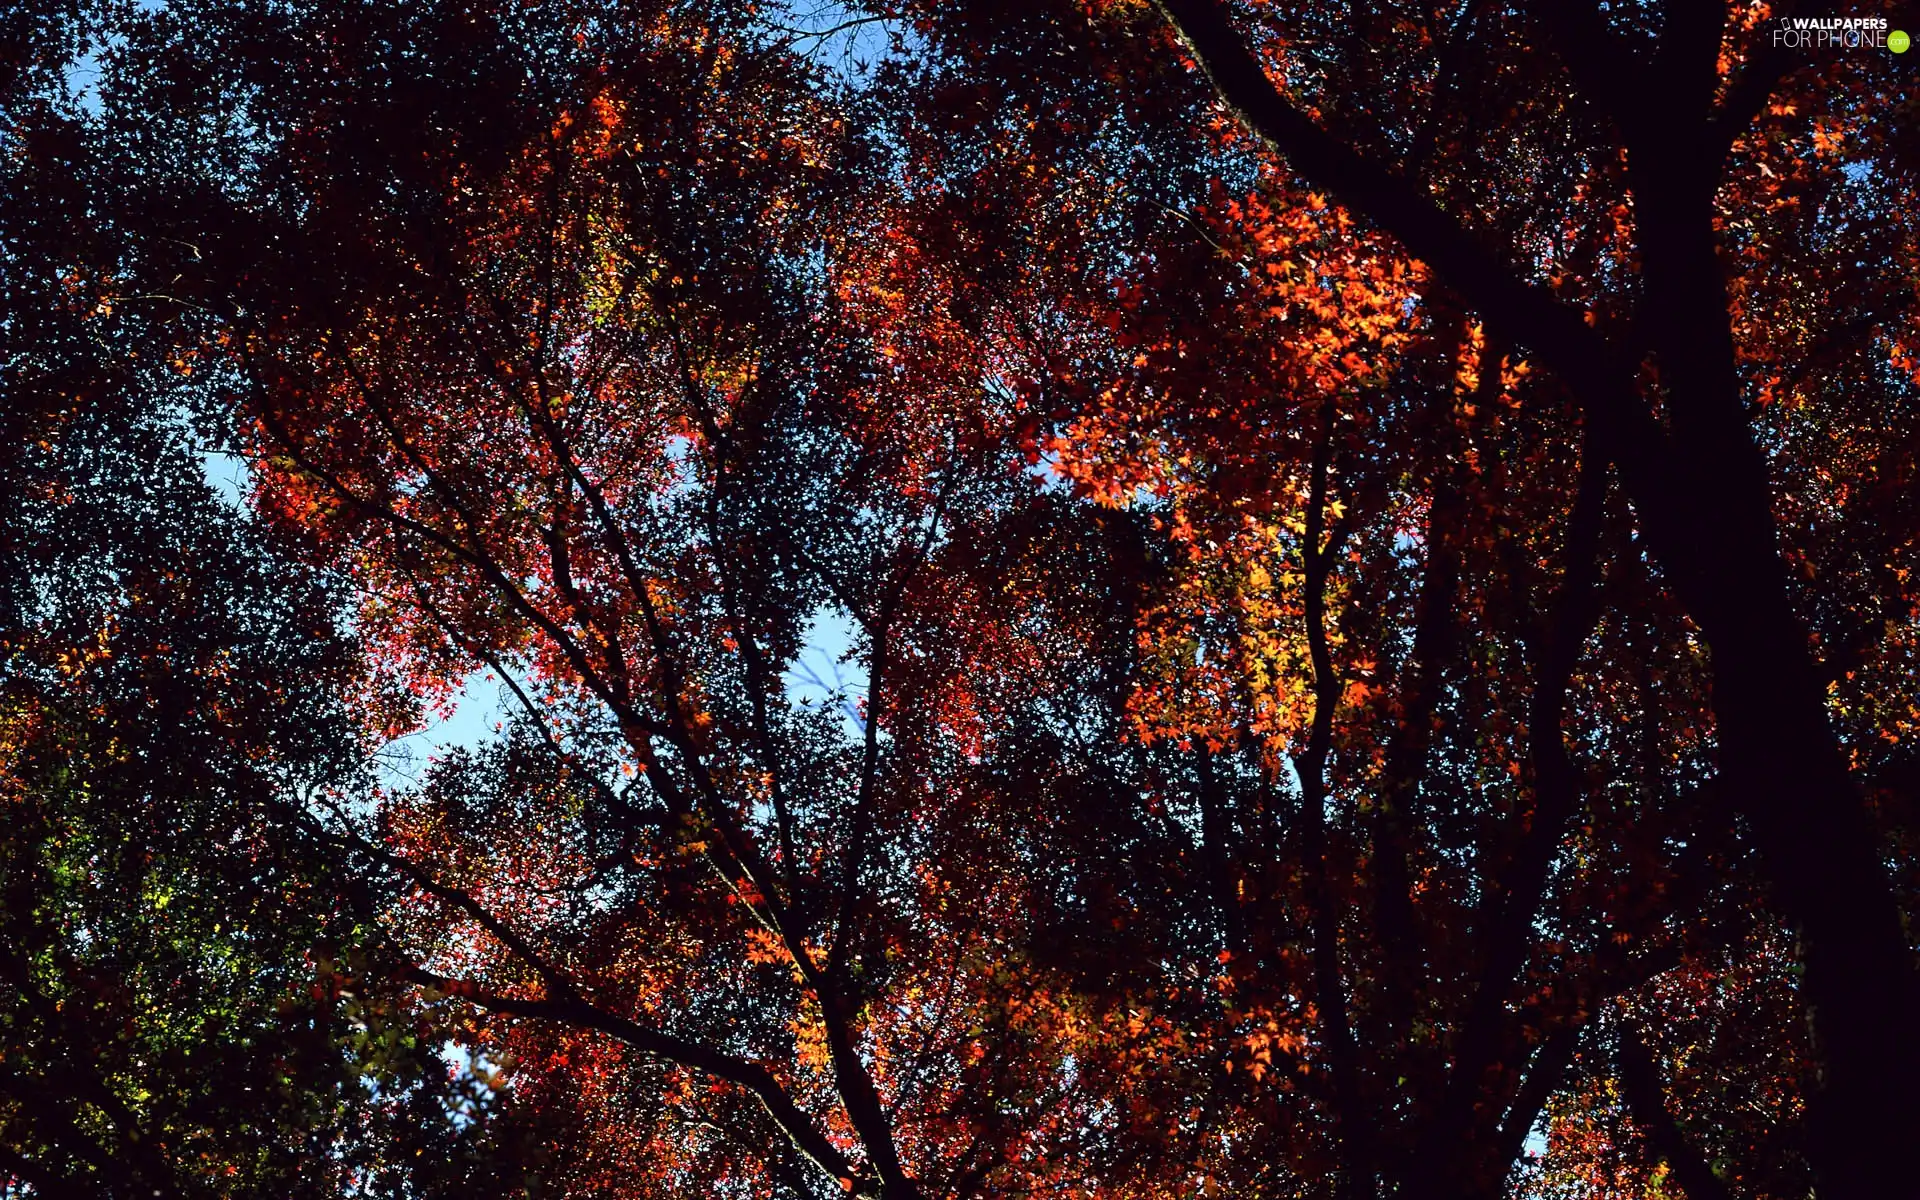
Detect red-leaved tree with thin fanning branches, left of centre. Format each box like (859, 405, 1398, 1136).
(93, 6, 1152, 1196)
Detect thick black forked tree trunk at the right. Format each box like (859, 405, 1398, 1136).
(1121, 2, 1916, 1194)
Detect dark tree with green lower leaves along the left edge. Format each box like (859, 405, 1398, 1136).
(0, 13, 538, 1198)
